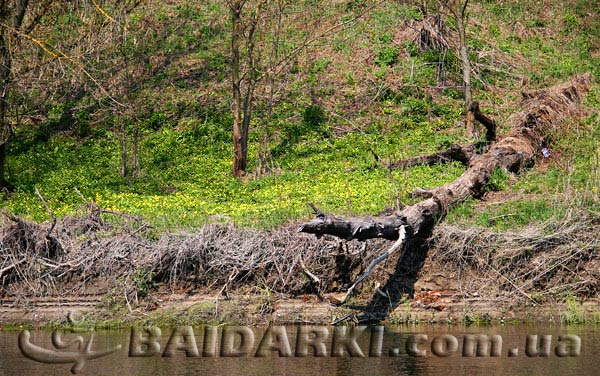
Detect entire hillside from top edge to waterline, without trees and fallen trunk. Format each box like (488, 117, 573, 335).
(0, 0, 600, 320)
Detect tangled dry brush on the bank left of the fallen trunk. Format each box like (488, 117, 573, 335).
(0, 204, 390, 297)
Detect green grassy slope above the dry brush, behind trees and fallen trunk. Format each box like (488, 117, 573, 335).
(2, 0, 600, 235)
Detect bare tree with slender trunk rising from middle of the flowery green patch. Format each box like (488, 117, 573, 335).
(225, 0, 386, 177)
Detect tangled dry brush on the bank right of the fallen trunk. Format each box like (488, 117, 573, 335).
(432, 209, 600, 300)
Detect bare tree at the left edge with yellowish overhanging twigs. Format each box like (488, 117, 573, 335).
(0, 0, 139, 190)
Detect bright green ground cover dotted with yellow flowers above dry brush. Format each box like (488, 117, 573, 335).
(4, 117, 461, 228)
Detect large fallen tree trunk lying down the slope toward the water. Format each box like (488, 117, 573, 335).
(300, 73, 592, 302)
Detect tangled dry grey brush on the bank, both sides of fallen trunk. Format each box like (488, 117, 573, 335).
(0, 200, 600, 308)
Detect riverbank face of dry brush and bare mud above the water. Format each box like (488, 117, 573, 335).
(0, 205, 600, 326)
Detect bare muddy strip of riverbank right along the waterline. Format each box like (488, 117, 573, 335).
(0, 292, 600, 329)
